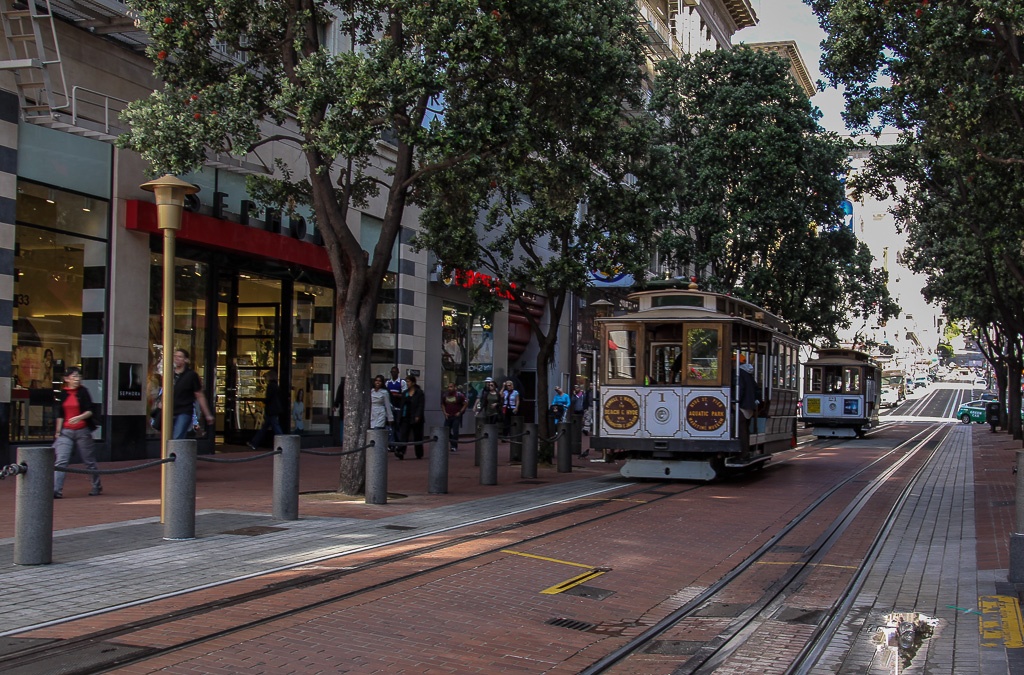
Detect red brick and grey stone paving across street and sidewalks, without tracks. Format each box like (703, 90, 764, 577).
(0, 426, 1020, 675)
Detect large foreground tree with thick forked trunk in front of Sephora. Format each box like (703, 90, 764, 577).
(122, 0, 655, 493)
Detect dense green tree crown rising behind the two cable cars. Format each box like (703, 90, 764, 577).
(643, 47, 898, 343)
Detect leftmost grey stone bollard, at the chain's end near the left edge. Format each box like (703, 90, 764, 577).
(14, 446, 54, 564)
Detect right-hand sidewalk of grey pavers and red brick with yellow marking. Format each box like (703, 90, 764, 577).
(817, 424, 1024, 675)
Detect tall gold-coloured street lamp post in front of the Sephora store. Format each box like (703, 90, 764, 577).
(139, 175, 199, 522)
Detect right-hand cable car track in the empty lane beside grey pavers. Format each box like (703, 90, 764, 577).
(580, 423, 949, 675)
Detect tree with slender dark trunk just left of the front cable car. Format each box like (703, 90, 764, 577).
(417, 107, 652, 460)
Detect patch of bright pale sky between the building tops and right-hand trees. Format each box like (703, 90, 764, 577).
(733, 0, 847, 134)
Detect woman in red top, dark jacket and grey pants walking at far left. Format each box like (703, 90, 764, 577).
(53, 366, 103, 499)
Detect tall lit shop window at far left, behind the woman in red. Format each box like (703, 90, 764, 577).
(11, 180, 109, 440)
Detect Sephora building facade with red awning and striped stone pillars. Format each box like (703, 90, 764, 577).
(0, 0, 570, 463)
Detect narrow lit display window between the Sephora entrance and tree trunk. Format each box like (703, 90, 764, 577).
(290, 284, 334, 433)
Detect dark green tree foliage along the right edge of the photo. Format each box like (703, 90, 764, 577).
(807, 0, 1024, 437)
